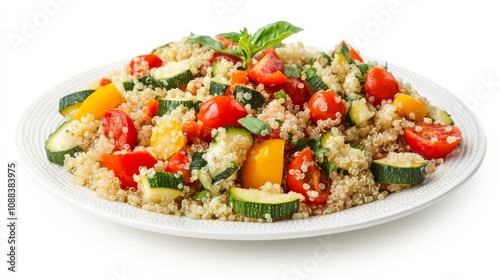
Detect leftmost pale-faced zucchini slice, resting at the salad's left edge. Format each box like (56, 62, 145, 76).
(45, 122, 83, 165)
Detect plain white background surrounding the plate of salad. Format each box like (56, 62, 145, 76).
(0, 0, 500, 280)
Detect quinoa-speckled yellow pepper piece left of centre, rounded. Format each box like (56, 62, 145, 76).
(149, 118, 187, 160)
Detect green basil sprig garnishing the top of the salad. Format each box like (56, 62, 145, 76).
(187, 21, 303, 65)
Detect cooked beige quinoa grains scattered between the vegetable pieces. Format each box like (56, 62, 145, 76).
(50, 26, 459, 222)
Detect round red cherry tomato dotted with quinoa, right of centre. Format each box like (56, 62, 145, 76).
(307, 90, 346, 122)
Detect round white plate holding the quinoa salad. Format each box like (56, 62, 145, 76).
(16, 59, 486, 240)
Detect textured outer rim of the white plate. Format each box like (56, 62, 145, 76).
(16, 57, 487, 241)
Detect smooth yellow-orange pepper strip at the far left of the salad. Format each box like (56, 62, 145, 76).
(75, 83, 126, 120)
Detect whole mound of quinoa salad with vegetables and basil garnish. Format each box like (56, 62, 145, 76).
(45, 21, 461, 222)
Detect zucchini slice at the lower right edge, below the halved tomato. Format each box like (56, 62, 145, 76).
(370, 153, 426, 185)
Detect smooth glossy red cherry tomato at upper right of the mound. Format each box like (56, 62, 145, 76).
(364, 67, 399, 106)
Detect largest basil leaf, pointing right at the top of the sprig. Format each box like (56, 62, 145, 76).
(252, 21, 303, 54)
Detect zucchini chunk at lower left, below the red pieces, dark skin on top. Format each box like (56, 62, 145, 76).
(139, 171, 184, 202)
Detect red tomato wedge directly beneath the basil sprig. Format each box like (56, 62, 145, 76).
(248, 47, 288, 86)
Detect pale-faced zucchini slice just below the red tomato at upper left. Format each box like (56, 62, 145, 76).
(151, 60, 194, 90)
